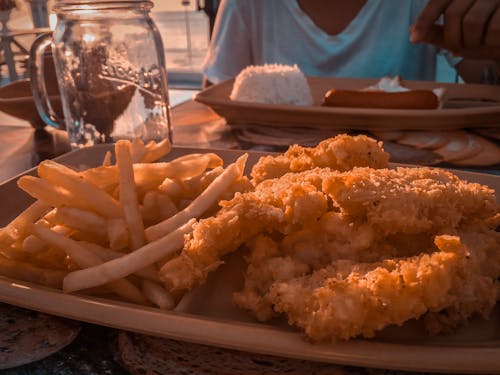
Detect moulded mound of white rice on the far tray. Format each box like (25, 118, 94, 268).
(229, 64, 313, 105)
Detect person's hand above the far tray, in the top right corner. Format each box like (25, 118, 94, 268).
(410, 0, 500, 61)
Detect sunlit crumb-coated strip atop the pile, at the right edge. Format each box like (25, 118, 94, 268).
(323, 168, 497, 234)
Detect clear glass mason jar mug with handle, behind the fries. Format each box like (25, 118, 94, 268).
(31, 0, 171, 147)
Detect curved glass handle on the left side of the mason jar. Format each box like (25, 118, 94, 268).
(30, 33, 64, 129)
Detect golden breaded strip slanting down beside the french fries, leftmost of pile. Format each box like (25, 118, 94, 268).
(160, 169, 335, 290)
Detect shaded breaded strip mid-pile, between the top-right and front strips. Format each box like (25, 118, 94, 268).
(233, 211, 437, 321)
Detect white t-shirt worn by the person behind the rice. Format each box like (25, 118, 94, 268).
(203, 0, 460, 83)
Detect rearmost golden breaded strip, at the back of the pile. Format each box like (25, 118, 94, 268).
(251, 134, 389, 184)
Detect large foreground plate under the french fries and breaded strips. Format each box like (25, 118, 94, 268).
(0, 147, 500, 373)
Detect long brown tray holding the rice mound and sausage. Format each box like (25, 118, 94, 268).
(195, 77, 500, 130)
